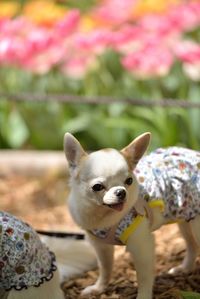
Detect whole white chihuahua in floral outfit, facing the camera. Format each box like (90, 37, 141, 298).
(64, 133, 200, 299)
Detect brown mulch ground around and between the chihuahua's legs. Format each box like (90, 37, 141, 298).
(0, 175, 200, 299)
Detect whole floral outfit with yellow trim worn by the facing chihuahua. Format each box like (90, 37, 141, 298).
(91, 147, 200, 245)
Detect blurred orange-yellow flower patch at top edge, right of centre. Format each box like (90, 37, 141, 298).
(132, 0, 181, 17)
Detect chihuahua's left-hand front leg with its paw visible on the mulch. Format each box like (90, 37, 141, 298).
(82, 235, 114, 296)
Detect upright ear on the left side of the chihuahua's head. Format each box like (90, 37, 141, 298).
(64, 133, 87, 172)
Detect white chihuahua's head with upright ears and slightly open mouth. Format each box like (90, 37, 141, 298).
(64, 133, 150, 211)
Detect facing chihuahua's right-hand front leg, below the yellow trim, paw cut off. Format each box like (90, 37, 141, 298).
(127, 218, 155, 299)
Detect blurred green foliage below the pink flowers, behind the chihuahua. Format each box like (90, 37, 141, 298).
(0, 52, 200, 150)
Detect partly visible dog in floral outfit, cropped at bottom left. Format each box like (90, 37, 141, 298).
(0, 211, 64, 299)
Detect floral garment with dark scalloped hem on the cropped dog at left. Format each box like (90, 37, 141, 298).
(0, 211, 57, 291)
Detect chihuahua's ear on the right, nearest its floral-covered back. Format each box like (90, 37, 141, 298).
(121, 132, 151, 169)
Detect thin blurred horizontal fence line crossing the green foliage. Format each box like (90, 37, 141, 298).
(0, 93, 200, 109)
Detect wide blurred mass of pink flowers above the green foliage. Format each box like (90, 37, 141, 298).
(0, 0, 200, 78)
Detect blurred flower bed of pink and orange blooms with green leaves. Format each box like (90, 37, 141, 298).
(0, 0, 200, 150)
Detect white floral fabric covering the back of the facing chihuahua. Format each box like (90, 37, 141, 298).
(135, 147, 200, 221)
